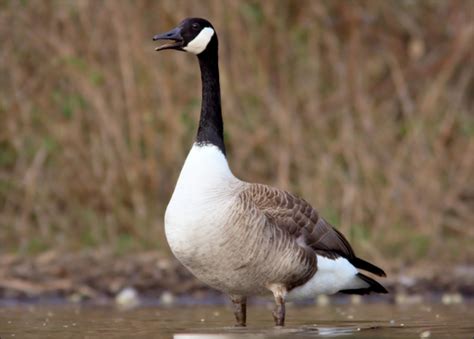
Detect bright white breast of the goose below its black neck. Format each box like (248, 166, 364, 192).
(165, 144, 239, 259)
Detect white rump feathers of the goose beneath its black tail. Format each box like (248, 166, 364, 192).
(288, 255, 368, 300)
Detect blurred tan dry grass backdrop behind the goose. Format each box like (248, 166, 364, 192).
(0, 0, 474, 269)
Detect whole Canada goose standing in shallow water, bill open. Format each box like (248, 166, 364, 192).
(153, 18, 387, 326)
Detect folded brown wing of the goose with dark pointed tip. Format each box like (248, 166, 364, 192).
(244, 184, 385, 276)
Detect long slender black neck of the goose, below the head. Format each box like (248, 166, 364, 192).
(196, 37, 225, 155)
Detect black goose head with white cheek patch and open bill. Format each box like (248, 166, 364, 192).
(153, 18, 217, 55)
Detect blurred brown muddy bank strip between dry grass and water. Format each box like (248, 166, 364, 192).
(0, 250, 474, 307)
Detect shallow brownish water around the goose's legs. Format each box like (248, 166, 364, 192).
(0, 304, 474, 339)
